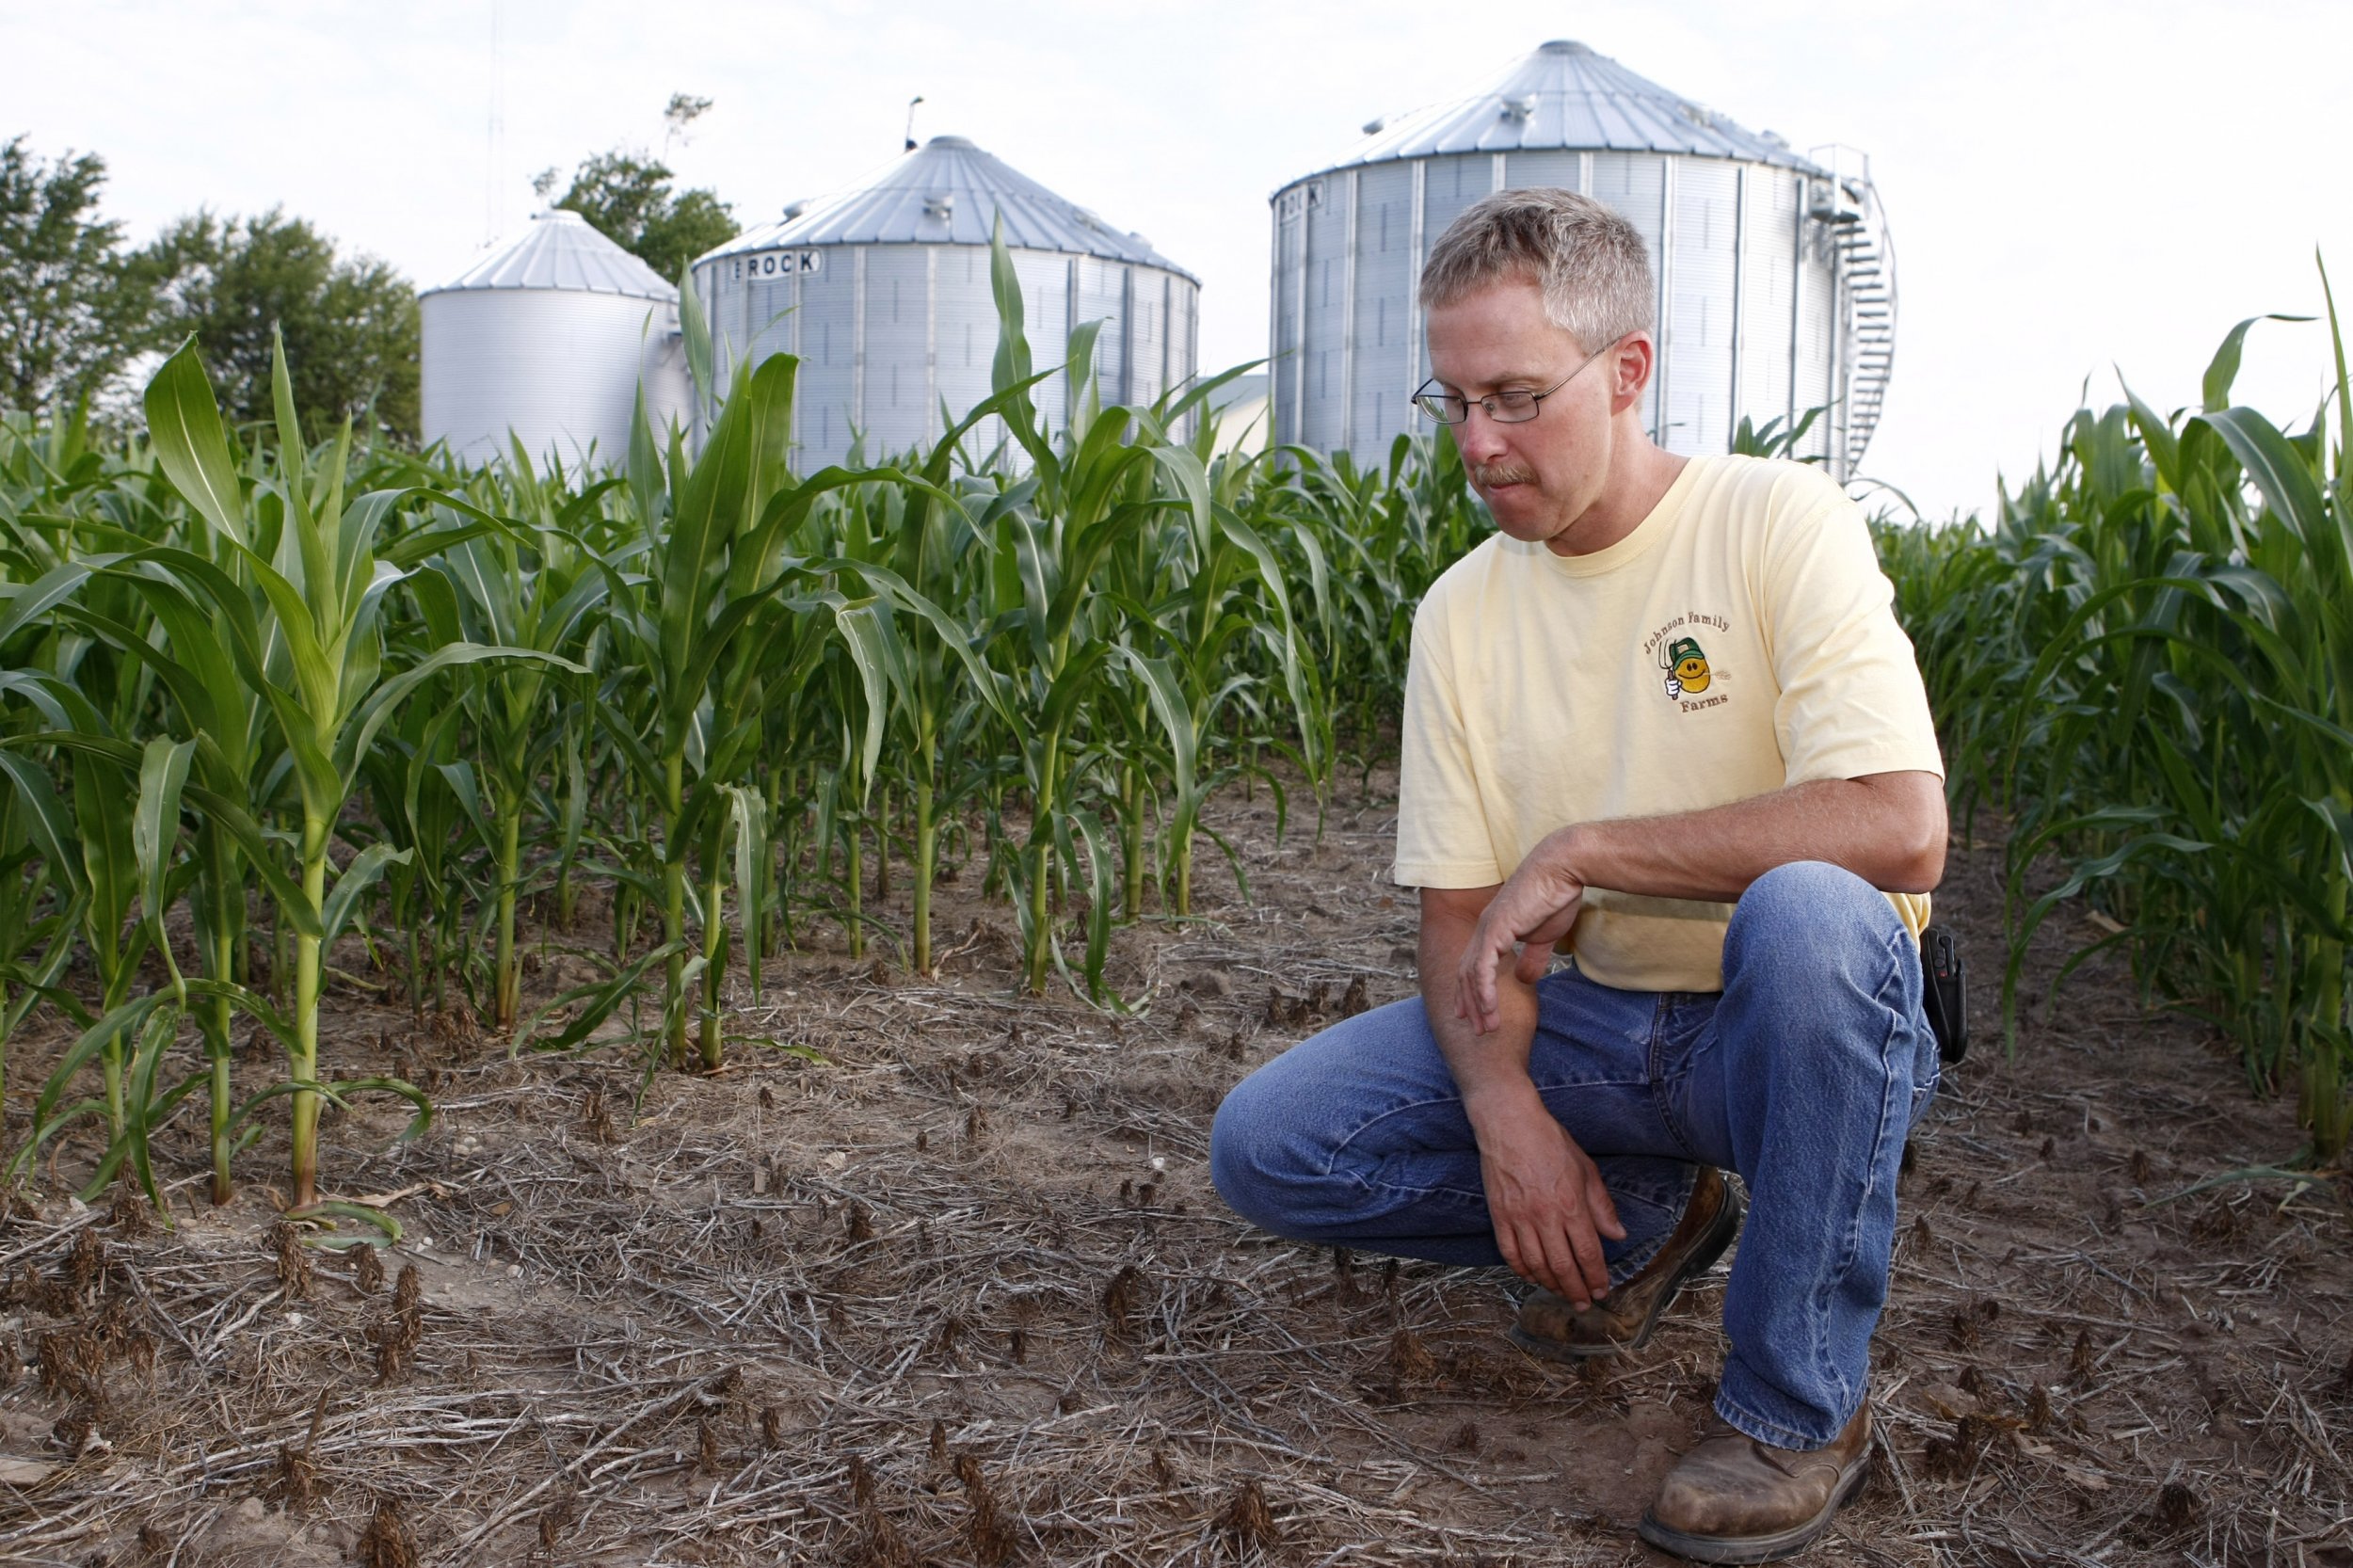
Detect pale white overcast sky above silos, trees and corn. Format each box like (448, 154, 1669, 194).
(0, 0, 2353, 516)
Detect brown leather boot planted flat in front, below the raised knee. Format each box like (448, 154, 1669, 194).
(1641, 1400, 1871, 1563)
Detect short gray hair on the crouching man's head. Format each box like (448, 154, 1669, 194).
(1421, 186, 1659, 353)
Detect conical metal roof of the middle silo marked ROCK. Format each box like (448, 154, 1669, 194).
(696, 136, 1198, 282)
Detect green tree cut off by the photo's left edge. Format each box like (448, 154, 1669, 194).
(0, 136, 155, 409)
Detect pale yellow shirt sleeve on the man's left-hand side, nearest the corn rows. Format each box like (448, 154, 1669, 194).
(1391, 593, 1504, 888)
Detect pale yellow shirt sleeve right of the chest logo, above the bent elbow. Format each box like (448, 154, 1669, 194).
(1763, 463, 1944, 784)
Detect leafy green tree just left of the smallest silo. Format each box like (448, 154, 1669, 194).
(139, 207, 419, 440)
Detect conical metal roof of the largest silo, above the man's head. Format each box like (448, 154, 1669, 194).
(1332, 38, 1815, 172)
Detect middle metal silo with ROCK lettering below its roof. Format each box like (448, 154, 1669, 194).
(695, 136, 1200, 471)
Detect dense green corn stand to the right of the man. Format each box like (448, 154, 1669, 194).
(1881, 287, 2353, 1160)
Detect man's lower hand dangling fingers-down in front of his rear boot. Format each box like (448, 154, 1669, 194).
(1473, 1093, 1626, 1311)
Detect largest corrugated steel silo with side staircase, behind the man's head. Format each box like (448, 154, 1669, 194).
(1271, 42, 1895, 475)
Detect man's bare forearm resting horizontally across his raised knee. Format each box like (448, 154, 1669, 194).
(1537, 772, 1946, 902)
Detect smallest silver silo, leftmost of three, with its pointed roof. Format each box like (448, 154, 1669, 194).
(417, 207, 692, 464)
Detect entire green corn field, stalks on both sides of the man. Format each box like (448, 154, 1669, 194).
(0, 235, 2353, 1245)
